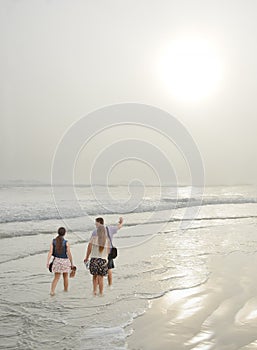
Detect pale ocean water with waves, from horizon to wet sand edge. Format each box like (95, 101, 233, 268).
(0, 185, 257, 350)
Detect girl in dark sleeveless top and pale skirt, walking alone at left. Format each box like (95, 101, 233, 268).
(47, 227, 73, 295)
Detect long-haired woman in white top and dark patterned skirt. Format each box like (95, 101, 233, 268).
(84, 225, 110, 295)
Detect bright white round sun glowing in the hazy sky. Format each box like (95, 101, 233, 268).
(159, 39, 222, 101)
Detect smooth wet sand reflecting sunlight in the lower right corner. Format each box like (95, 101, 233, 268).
(128, 252, 257, 350)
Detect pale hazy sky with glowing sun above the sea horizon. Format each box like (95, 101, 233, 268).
(0, 0, 257, 185)
